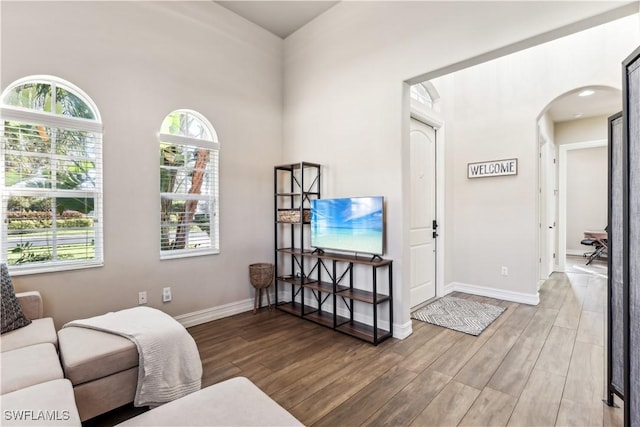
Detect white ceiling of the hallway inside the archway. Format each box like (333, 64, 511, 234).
(547, 86, 622, 122)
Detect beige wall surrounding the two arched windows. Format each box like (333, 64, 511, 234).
(0, 2, 282, 326)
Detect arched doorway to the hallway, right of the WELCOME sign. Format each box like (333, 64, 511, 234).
(537, 86, 621, 280)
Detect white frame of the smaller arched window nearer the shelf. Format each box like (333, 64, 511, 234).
(158, 108, 220, 261)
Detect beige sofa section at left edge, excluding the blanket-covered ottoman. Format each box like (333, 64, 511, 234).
(0, 292, 81, 426)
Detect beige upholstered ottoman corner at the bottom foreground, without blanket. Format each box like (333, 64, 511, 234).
(118, 377, 303, 427)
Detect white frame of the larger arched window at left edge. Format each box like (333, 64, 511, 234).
(0, 75, 104, 276)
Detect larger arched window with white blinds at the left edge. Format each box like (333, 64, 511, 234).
(0, 76, 103, 274)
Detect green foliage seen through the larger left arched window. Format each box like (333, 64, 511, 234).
(2, 82, 101, 264)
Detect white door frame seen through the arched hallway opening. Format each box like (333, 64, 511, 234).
(556, 139, 607, 272)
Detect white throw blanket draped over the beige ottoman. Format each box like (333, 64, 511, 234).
(63, 307, 202, 407)
